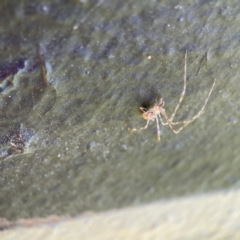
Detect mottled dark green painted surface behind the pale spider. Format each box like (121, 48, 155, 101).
(0, 0, 240, 219)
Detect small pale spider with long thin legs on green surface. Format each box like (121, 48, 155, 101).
(128, 51, 216, 141)
